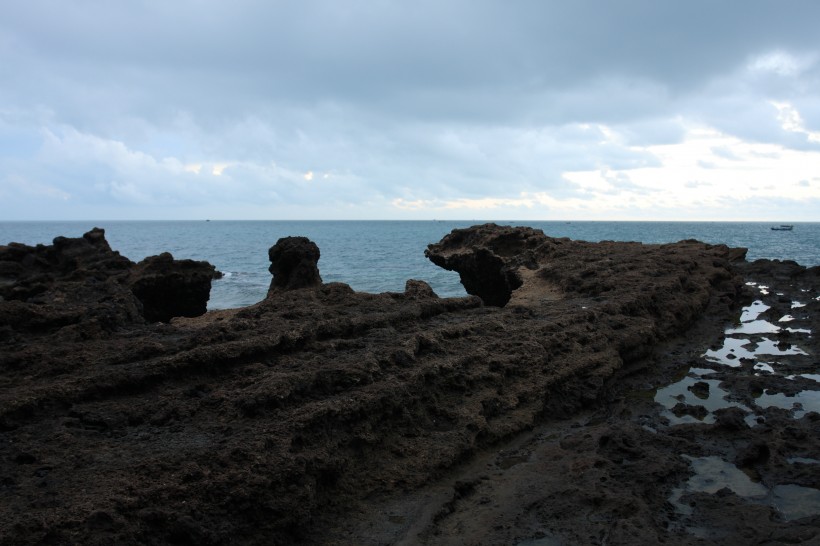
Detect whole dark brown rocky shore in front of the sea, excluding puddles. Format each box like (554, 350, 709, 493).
(0, 225, 820, 545)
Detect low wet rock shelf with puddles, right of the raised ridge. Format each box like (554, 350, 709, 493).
(342, 253, 820, 546)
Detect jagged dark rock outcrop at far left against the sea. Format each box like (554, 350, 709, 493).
(0, 228, 218, 337)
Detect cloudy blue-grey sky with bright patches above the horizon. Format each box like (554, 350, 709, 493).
(0, 0, 820, 222)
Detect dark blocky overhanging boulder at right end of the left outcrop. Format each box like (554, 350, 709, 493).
(129, 252, 218, 322)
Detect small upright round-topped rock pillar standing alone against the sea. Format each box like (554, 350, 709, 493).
(268, 237, 322, 295)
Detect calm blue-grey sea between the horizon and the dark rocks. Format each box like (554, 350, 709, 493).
(0, 221, 820, 309)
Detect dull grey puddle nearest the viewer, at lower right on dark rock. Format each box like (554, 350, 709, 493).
(669, 455, 820, 521)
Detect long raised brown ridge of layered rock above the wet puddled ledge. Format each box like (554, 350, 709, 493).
(0, 225, 760, 544)
